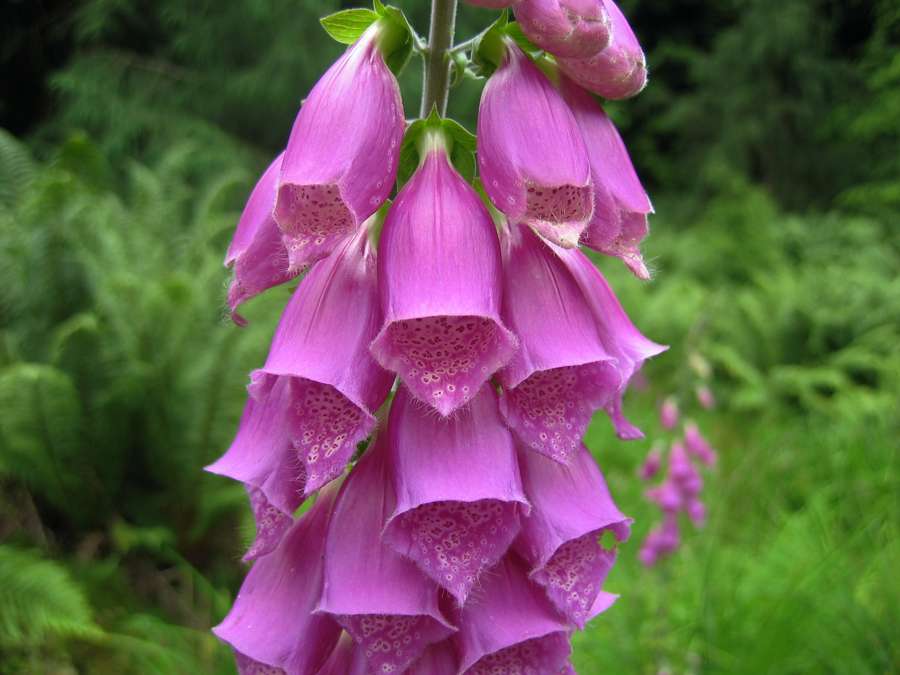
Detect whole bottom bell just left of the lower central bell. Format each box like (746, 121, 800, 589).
(317, 433, 455, 673)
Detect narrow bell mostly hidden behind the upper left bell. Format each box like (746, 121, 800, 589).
(225, 153, 301, 326)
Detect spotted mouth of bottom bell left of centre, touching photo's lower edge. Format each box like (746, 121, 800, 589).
(337, 614, 445, 673)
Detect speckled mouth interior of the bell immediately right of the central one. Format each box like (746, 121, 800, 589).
(505, 364, 603, 463)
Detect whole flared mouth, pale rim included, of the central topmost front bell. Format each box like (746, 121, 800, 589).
(371, 316, 516, 417)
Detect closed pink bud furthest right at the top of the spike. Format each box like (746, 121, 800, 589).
(558, 0, 647, 99)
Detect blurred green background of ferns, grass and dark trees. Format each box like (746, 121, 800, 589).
(0, 0, 900, 675)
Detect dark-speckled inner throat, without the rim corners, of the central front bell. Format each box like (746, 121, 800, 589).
(390, 316, 500, 408)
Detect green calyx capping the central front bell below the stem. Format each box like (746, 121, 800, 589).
(397, 108, 477, 188)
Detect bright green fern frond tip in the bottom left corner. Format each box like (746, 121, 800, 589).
(0, 546, 104, 648)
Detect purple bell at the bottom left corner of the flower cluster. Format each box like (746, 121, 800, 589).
(213, 484, 341, 675)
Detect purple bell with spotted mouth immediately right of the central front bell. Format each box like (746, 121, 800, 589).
(497, 225, 621, 463)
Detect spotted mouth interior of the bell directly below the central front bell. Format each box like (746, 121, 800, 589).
(391, 499, 519, 601)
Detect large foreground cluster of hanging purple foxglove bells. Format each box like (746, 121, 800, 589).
(208, 5, 660, 675)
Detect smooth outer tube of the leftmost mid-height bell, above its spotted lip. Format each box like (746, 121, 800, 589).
(206, 371, 305, 518)
